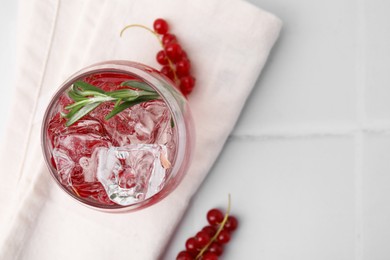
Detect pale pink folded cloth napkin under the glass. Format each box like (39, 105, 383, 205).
(0, 0, 281, 260)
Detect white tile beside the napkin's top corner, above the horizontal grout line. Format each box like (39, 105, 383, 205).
(235, 0, 356, 134)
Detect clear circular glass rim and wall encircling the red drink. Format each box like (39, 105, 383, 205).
(41, 60, 193, 213)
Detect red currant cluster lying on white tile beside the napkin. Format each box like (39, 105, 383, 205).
(176, 209, 238, 260)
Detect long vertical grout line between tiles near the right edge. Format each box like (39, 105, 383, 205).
(354, 0, 367, 260)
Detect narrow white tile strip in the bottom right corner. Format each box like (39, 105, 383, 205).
(362, 135, 390, 260)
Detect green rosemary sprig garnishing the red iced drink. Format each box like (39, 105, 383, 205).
(62, 80, 160, 126)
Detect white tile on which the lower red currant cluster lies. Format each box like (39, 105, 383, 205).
(164, 137, 355, 260)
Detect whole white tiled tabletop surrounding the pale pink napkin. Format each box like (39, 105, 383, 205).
(0, 0, 390, 260)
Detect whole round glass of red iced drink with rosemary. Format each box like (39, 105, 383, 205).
(42, 61, 191, 211)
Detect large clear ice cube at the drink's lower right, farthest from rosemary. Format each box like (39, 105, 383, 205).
(97, 144, 170, 206)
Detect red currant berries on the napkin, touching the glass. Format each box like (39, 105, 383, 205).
(153, 18, 195, 96)
